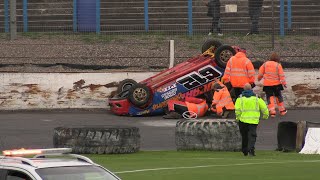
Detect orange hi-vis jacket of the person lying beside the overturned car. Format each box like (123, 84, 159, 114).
(185, 97, 208, 117)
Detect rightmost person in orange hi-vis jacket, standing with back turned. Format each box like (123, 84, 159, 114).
(258, 53, 287, 117)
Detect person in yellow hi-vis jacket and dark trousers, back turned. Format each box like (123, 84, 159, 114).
(235, 83, 269, 156)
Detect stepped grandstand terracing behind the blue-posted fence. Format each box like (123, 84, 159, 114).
(0, 0, 320, 35)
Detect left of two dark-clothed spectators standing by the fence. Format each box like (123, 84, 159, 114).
(206, 0, 223, 36)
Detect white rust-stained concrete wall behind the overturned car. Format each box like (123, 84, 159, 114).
(0, 70, 320, 110)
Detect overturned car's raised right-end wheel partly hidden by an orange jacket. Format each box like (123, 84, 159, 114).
(214, 45, 236, 68)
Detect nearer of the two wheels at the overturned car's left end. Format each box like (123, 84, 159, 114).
(128, 84, 151, 107)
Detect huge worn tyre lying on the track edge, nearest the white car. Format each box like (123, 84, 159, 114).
(53, 127, 140, 154)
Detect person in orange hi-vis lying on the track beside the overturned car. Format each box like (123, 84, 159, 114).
(163, 97, 208, 119)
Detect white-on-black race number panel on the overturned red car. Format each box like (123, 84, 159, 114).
(177, 65, 221, 89)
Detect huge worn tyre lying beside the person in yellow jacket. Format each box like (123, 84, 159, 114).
(175, 119, 241, 151)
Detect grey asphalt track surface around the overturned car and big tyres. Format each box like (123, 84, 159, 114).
(0, 109, 320, 151)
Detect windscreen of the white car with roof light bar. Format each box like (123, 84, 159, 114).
(36, 166, 117, 180)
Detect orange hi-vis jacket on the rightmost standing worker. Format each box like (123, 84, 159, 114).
(258, 61, 286, 86)
